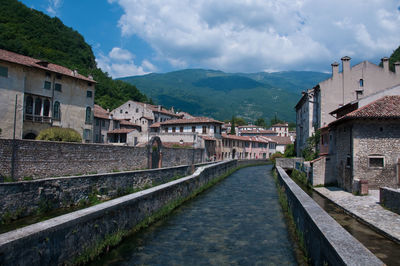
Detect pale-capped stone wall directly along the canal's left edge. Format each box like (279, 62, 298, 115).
(0, 160, 237, 266)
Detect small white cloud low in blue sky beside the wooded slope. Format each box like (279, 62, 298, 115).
(96, 47, 157, 78)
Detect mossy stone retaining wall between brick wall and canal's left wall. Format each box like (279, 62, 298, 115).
(0, 162, 211, 222)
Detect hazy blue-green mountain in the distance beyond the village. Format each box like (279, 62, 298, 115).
(121, 69, 330, 121)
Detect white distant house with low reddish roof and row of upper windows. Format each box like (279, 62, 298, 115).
(150, 117, 223, 160)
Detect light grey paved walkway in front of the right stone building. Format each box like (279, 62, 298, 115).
(314, 187, 400, 243)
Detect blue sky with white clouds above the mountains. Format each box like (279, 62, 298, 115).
(21, 0, 400, 78)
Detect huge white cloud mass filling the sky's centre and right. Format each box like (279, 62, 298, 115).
(108, 0, 400, 72)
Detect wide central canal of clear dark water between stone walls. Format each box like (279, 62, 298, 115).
(92, 165, 297, 265)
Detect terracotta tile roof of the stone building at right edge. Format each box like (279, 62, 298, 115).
(329, 95, 400, 125)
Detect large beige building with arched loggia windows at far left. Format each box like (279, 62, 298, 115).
(0, 49, 95, 142)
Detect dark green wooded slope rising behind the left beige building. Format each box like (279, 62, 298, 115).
(0, 0, 149, 109)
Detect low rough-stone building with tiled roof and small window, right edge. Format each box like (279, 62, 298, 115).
(323, 96, 400, 191)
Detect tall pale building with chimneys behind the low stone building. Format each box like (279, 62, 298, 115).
(295, 56, 400, 154)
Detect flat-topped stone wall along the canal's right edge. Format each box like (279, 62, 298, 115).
(277, 167, 383, 265)
